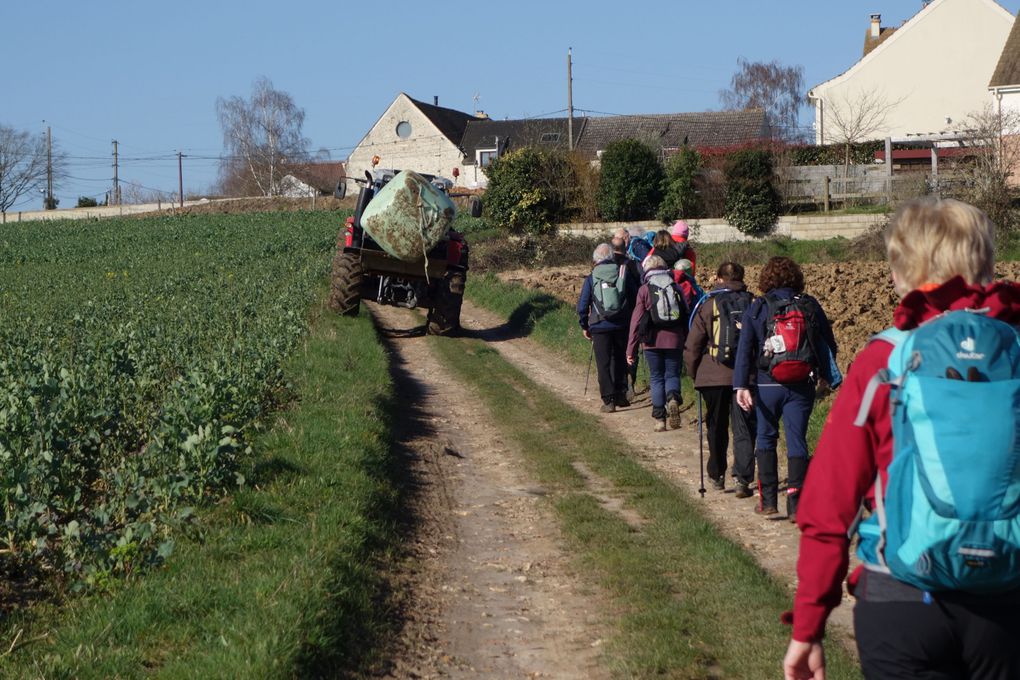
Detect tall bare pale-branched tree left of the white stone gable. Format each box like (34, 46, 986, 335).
(216, 76, 308, 196)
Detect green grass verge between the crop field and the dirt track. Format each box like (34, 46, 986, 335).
(0, 309, 400, 678)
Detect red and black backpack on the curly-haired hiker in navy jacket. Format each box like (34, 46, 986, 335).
(759, 294, 818, 384)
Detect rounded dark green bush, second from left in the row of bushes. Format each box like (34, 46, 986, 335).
(598, 140, 665, 220)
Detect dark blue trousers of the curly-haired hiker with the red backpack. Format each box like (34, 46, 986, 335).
(755, 382, 815, 458)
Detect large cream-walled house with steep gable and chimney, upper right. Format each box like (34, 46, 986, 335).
(808, 0, 1014, 144)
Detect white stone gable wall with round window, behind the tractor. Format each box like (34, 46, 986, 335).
(347, 94, 469, 195)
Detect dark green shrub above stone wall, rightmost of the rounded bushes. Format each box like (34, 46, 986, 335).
(725, 149, 781, 236)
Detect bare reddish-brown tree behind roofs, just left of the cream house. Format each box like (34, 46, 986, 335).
(719, 57, 804, 142)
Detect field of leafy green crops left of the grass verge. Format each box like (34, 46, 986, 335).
(0, 213, 340, 586)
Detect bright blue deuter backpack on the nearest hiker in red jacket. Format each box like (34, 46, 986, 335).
(854, 310, 1020, 593)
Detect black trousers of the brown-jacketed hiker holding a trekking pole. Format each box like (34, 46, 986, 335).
(698, 385, 756, 484)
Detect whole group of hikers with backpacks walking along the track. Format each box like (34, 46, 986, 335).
(577, 199, 1020, 680)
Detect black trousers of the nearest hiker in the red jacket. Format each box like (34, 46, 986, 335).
(854, 573, 1020, 680)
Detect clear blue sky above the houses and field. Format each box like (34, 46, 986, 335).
(0, 0, 1020, 210)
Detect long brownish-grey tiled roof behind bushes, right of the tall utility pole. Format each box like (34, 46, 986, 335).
(577, 109, 770, 159)
